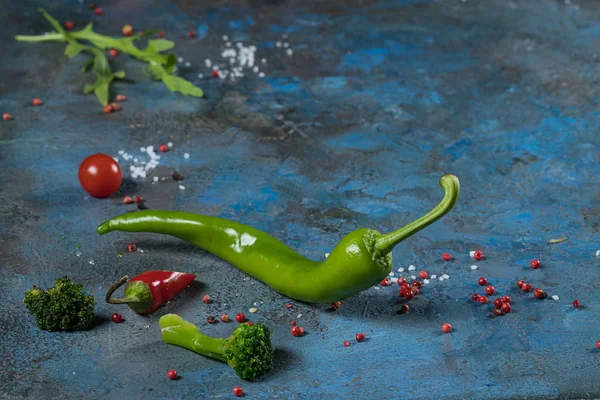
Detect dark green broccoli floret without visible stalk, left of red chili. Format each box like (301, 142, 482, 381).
(23, 277, 96, 331)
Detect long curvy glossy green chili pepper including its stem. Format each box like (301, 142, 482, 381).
(98, 175, 460, 303)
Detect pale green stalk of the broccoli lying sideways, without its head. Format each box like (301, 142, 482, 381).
(158, 314, 226, 361)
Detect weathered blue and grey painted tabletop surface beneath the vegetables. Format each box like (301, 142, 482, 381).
(0, 0, 600, 399)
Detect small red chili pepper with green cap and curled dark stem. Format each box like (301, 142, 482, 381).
(106, 271, 196, 314)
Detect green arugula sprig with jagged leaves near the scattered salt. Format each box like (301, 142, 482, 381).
(15, 9, 204, 105)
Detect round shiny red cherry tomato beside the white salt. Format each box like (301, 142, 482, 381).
(79, 153, 123, 197)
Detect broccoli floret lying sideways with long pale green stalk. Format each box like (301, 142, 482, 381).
(158, 314, 274, 380)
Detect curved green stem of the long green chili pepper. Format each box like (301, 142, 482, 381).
(375, 174, 460, 254)
